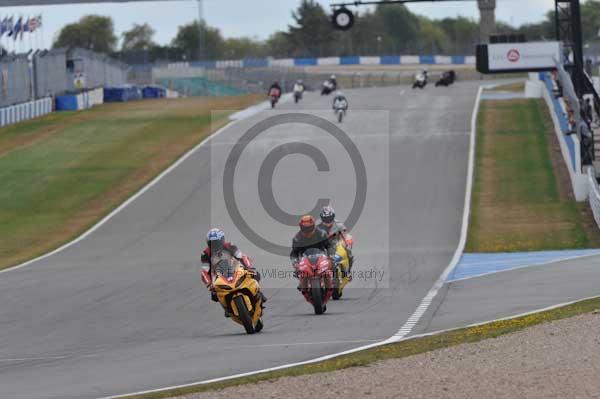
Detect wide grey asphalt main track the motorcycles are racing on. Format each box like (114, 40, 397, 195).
(0, 82, 478, 399)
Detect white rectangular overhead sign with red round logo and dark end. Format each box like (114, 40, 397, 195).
(477, 42, 561, 73)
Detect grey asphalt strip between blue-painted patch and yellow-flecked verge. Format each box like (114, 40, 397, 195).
(420, 255, 600, 333)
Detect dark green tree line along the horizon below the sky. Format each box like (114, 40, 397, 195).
(53, 0, 600, 62)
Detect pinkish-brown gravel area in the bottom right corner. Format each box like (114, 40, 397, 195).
(177, 311, 600, 399)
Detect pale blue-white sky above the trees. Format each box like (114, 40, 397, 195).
(0, 0, 554, 47)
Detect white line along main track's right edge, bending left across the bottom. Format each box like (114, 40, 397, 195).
(99, 86, 483, 399)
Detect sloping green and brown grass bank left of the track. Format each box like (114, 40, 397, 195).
(0, 96, 259, 269)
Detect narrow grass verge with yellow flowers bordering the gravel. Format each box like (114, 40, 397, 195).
(118, 298, 600, 399)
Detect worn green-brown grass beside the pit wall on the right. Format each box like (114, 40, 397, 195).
(466, 100, 600, 252)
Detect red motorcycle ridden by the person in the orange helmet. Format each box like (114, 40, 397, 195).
(296, 248, 334, 314)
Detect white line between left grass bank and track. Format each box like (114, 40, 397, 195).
(0, 115, 244, 274)
